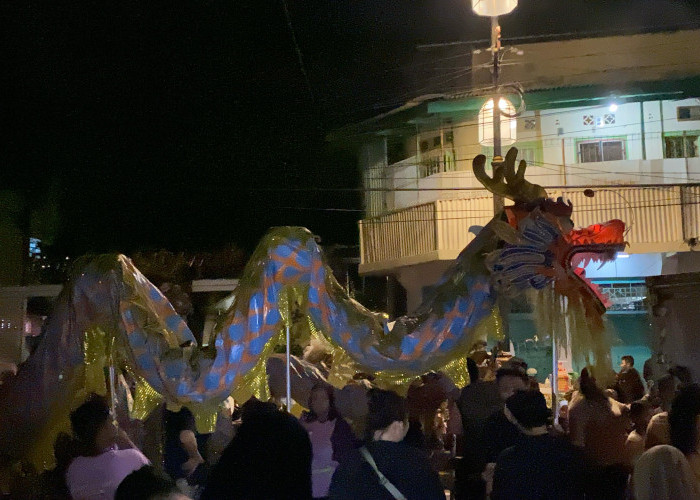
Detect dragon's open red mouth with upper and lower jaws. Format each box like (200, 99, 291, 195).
(562, 219, 627, 312)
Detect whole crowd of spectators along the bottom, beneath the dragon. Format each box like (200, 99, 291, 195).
(0, 356, 700, 500)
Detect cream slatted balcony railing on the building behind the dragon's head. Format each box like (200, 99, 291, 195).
(359, 184, 700, 274)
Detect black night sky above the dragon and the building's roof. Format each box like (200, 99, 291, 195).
(0, 0, 700, 255)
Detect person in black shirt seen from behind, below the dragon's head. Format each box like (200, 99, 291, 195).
(490, 390, 584, 500)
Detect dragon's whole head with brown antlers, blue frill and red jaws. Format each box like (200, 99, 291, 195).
(474, 148, 626, 317)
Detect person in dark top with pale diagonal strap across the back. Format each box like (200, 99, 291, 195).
(329, 389, 445, 500)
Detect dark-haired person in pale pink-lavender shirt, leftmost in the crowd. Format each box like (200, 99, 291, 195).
(66, 395, 150, 500)
